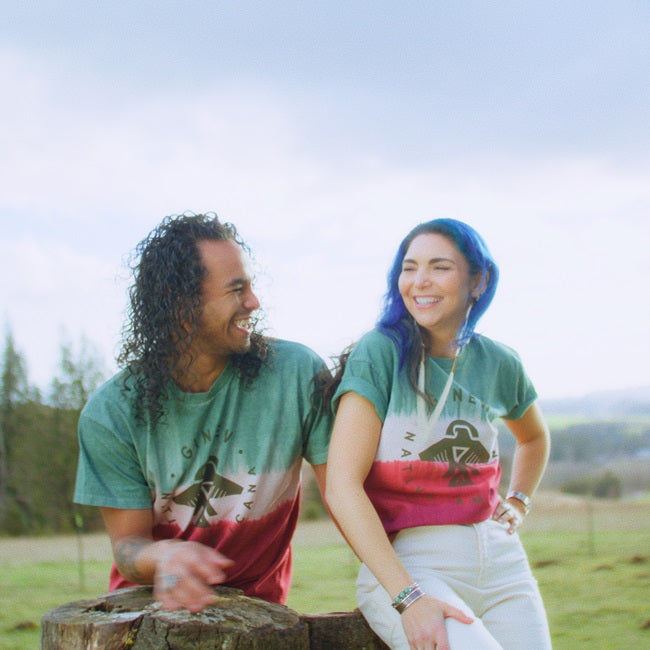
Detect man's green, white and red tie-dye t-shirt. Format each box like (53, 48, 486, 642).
(75, 340, 331, 603)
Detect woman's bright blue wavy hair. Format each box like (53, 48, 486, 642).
(377, 219, 499, 368)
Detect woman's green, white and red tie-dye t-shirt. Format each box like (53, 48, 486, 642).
(334, 330, 537, 533)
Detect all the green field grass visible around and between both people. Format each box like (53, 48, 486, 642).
(0, 527, 650, 650)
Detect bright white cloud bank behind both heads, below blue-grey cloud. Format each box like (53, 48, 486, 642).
(0, 43, 650, 396)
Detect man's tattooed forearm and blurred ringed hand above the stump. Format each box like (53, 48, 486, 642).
(101, 508, 233, 612)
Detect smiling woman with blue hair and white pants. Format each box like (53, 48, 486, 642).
(327, 219, 551, 650)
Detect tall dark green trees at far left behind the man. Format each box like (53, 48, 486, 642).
(0, 330, 103, 535)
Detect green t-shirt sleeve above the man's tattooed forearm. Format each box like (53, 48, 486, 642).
(74, 413, 152, 510)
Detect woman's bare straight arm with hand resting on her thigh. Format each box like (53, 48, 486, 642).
(326, 392, 472, 650)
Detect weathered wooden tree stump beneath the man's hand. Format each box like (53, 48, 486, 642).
(41, 587, 387, 650)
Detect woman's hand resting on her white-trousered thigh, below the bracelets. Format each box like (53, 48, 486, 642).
(402, 594, 474, 650)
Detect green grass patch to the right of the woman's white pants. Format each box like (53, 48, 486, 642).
(522, 528, 650, 650)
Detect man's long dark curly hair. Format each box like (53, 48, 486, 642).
(117, 213, 269, 424)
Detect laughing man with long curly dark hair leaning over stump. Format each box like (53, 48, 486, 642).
(75, 215, 331, 612)
